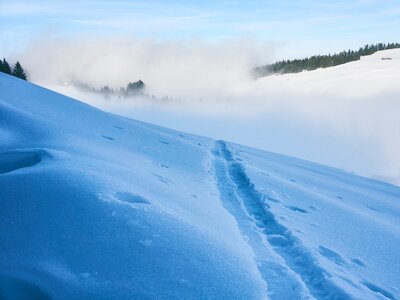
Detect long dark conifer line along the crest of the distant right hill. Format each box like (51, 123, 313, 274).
(255, 43, 400, 77)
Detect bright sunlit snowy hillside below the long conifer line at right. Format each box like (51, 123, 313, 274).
(258, 49, 400, 97)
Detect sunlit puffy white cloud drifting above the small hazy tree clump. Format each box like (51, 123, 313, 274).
(18, 38, 274, 100)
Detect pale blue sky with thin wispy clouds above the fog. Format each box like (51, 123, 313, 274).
(0, 0, 400, 57)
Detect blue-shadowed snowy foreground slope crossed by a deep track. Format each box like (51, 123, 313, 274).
(0, 74, 400, 299)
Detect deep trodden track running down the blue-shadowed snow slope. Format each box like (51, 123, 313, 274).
(213, 141, 351, 299)
